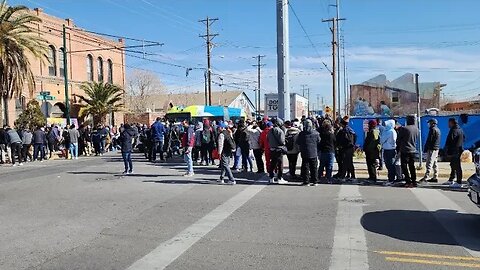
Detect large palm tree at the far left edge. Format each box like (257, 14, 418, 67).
(0, 0, 48, 123)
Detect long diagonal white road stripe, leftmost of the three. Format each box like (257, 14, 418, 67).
(128, 185, 266, 270)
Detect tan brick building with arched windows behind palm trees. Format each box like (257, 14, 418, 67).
(3, 8, 125, 125)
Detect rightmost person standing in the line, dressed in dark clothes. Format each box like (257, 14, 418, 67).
(444, 118, 465, 188)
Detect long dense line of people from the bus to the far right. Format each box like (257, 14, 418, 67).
(142, 116, 464, 188)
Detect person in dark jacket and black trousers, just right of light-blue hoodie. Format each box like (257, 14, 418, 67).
(397, 115, 419, 188)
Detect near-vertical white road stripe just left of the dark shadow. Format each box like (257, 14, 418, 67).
(330, 185, 369, 270)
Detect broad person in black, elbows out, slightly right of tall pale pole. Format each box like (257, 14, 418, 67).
(296, 119, 320, 186)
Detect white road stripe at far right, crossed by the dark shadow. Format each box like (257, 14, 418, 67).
(412, 188, 480, 257)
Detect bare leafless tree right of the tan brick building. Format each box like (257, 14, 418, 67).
(126, 70, 165, 112)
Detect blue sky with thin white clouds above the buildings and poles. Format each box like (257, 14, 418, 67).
(9, 0, 480, 105)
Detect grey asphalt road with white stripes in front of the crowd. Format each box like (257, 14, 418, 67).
(0, 155, 480, 270)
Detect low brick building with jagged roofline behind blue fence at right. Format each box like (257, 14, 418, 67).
(350, 73, 446, 116)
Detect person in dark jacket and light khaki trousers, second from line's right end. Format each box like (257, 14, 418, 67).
(420, 118, 441, 184)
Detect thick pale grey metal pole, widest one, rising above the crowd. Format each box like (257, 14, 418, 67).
(277, 0, 290, 120)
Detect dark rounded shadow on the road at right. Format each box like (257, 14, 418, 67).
(361, 210, 480, 251)
